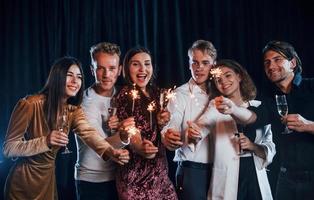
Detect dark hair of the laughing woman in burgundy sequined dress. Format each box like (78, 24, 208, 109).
(123, 47, 156, 88)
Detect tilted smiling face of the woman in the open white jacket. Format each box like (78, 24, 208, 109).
(215, 66, 241, 98)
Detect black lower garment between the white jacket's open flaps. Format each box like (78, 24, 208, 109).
(237, 156, 262, 200)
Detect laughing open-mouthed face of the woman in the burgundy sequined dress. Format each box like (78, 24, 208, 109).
(129, 53, 153, 90)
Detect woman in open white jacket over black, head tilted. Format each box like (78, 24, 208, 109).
(208, 60, 276, 200)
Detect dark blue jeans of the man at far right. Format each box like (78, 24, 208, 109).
(276, 167, 314, 200)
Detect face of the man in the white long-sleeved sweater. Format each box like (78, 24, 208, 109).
(92, 52, 121, 96)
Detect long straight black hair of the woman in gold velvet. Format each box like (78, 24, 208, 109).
(39, 57, 85, 129)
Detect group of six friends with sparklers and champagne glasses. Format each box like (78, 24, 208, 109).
(3, 40, 314, 200)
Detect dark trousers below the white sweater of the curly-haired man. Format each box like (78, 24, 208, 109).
(75, 180, 118, 200)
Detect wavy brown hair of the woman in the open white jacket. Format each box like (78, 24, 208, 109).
(210, 59, 256, 101)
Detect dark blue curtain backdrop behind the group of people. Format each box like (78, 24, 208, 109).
(0, 0, 314, 196)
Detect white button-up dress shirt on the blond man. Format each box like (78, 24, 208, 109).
(161, 79, 212, 163)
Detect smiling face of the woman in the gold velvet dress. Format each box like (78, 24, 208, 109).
(65, 65, 82, 99)
